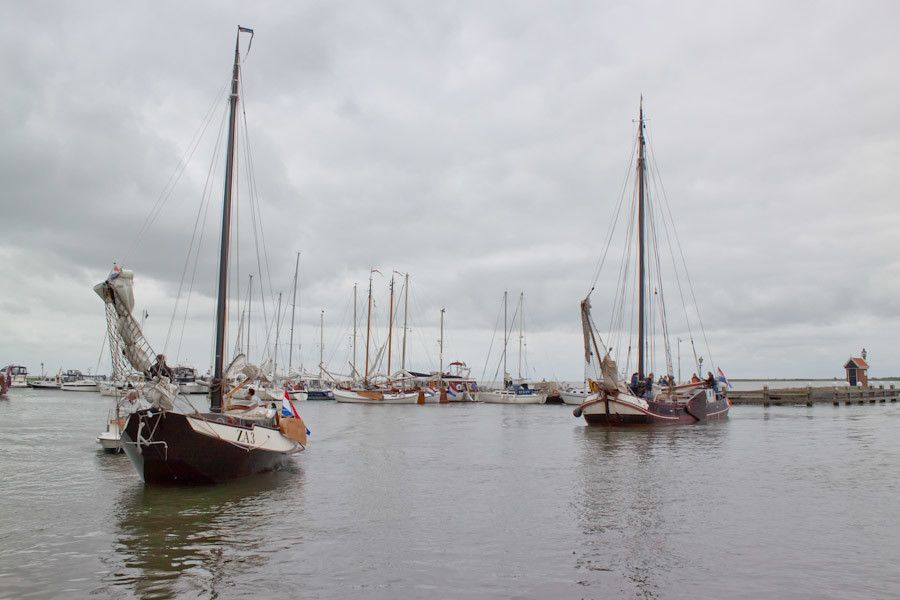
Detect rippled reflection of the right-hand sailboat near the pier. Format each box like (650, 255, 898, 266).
(574, 423, 728, 598)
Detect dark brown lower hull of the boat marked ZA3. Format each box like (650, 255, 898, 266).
(122, 411, 290, 485)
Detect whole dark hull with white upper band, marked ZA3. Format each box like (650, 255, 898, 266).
(122, 409, 303, 484)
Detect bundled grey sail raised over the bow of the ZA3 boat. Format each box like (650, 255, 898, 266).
(94, 265, 155, 373)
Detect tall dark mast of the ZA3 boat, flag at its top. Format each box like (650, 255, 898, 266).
(209, 27, 253, 412)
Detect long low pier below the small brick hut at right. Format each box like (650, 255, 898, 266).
(728, 385, 900, 406)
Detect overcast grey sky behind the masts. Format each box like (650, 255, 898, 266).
(0, 0, 900, 379)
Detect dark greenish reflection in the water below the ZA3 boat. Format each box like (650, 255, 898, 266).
(97, 461, 304, 598)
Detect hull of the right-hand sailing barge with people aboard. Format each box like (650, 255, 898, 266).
(574, 389, 731, 427)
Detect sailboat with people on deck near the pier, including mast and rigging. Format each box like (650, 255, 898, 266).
(574, 99, 730, 427)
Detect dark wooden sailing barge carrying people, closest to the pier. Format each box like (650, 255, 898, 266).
(573, 98, 731, 427)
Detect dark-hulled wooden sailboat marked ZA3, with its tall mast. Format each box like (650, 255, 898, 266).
(95, 27, 306, 484)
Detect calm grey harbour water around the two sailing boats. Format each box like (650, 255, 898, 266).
(0, 390, 900, 599)
